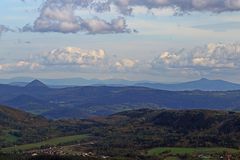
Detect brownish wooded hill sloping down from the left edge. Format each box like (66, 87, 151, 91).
(0, 106, 49, 148)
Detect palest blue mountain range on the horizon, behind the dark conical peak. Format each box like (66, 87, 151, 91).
(0, 77, 240, 91)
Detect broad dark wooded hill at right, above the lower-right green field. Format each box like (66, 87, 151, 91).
(91, 109, 240, 149)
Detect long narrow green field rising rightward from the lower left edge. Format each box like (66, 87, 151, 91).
(0, 135, 88, 153)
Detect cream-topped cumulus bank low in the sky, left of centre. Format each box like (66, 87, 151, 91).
(38, 47, 138, 72)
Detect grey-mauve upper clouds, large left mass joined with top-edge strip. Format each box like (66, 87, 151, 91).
(21, 0, 240, 34)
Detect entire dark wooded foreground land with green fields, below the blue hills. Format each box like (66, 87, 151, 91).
(0, 107, 240, 160)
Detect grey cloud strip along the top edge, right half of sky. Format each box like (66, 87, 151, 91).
(109, 0, 240, 15)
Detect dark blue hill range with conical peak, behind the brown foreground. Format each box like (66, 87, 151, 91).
(0, 80, 240, 118)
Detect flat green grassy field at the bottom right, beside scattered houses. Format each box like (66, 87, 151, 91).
(148, 147, 240, 156)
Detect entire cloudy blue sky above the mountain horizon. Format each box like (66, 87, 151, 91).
(0, 0, 240, 83)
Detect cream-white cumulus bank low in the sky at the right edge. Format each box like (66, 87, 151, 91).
(152, 43, 240, 72)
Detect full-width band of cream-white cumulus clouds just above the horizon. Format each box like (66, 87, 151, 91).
(0, 43, 240, 77)
